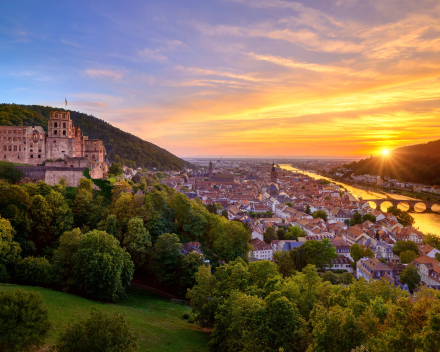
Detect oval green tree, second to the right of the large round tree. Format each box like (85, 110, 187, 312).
(153, 233, 182, 285)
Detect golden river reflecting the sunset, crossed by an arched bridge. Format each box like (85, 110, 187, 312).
(279, 164, 440, 235)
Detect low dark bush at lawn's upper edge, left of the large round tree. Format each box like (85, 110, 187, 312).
(15, 257, 55, 287)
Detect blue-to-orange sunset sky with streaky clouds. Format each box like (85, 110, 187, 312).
(0, 0, 440, 158)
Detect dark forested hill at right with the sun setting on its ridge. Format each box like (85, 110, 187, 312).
(346, 140, 440, 185)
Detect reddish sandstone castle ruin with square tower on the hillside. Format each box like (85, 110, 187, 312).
(0, 111, 108, 186)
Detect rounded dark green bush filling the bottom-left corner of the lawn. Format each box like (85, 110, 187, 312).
(0, 290, 51, 352)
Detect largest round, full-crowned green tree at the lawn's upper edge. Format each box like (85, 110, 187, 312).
(71, 230, 134, 302)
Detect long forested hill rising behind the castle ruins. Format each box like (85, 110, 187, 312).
(0, 104, 190, 170)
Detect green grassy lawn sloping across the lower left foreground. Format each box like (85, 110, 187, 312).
(0, 284, 209, 352)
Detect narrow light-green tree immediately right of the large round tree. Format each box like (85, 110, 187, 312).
(123, 218, 151, 268)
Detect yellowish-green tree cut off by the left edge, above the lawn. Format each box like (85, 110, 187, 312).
(0, 216, 21, 282)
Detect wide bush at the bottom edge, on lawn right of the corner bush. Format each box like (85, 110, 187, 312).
(53, 309, 139, 352)
